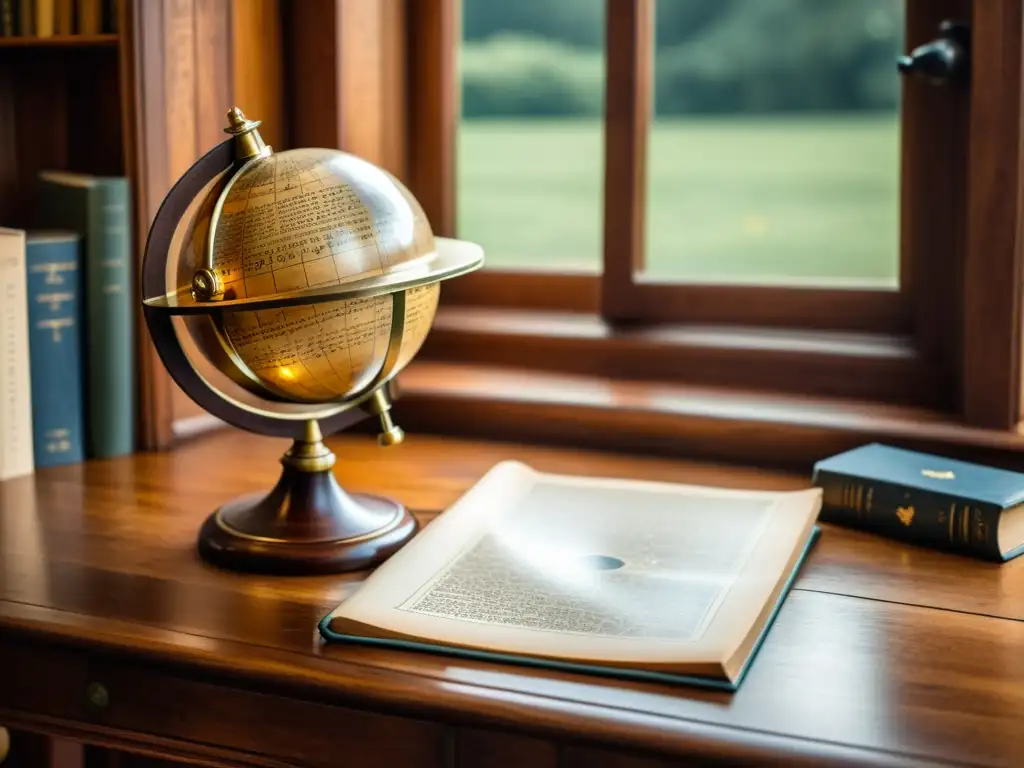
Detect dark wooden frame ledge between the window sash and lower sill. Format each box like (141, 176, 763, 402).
(419, 309, 943, 408)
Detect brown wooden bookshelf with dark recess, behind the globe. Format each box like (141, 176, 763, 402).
(0, 0, 232, 449)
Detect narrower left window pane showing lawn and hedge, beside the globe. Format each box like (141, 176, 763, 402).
(456, 0, 604, 271)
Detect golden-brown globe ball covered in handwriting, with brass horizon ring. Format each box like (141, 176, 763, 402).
(143, 110, 482, 438)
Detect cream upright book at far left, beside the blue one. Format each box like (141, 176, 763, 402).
(0, 228, 34, 480)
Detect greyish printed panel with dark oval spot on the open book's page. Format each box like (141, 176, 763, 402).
(397, 484, 770, 641)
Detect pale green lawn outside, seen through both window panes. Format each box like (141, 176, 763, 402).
(458, 116, 899, 285)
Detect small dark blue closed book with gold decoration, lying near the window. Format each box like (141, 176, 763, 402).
(813, 443, 1024, 562)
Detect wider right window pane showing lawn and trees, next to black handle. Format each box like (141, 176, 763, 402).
(645, 0, 903, 287)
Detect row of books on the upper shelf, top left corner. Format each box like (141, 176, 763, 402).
(0, 0, 119, 37)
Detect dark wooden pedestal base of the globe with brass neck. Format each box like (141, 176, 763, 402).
(199, 421, 417, 574)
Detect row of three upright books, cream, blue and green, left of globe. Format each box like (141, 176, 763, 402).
(0, 172, 135, 479)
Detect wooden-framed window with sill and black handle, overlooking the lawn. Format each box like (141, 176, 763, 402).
(214, 0, 1024, 461)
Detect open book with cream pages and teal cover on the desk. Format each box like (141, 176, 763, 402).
(321, 462, 821, 689)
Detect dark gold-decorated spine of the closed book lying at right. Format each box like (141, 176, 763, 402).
(813, 470, 1002, 561)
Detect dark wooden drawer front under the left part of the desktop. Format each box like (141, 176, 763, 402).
(82, 658, 444, 768)
